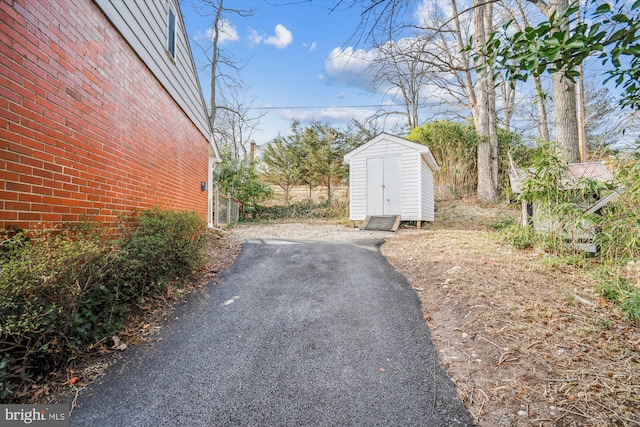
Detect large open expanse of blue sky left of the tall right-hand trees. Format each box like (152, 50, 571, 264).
(182, 0, 410, 144)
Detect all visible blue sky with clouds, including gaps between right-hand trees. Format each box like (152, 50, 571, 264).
(181, 0, 637, 150)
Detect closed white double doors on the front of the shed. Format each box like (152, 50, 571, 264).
(367, 156, 402, 216)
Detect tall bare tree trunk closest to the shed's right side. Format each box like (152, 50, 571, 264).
(473, 0, 497, 202)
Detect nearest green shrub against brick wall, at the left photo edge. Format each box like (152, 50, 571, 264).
(0, 229, 124, 398)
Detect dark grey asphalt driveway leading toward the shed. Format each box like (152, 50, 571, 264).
(71, 240, 472, 427)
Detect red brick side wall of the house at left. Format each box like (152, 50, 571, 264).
(0, 0, 208, 229)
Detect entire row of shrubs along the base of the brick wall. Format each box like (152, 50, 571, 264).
(0, 208, 206, 403)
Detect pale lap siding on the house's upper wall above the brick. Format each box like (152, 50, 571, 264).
(95, 0, 211, 140)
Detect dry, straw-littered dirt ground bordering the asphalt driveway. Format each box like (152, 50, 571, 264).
(46, 201, 640, 427)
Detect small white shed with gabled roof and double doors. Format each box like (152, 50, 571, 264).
(344, 133, 438, 221)
